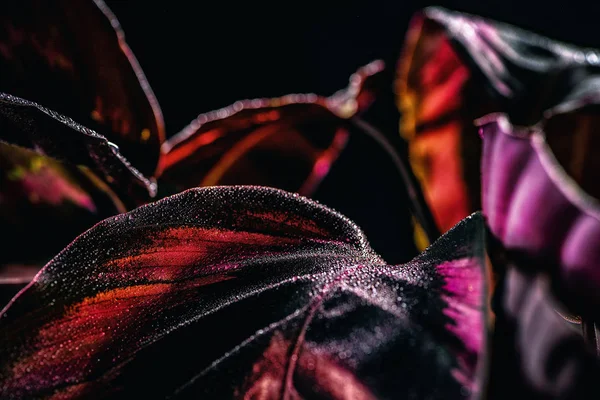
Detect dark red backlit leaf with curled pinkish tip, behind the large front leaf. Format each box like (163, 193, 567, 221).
(159, 61, 383, 195)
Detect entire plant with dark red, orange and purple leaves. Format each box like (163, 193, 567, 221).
(0, 0, 600, 399)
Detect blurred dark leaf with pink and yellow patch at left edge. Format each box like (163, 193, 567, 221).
(0, 143, 125, 305)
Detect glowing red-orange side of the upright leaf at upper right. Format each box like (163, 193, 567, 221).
(396, 8, 489, 238)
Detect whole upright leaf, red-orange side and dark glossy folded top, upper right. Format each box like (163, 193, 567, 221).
(397, 8, 600, 244)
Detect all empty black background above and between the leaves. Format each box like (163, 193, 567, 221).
(102, 0, 600, 262)
